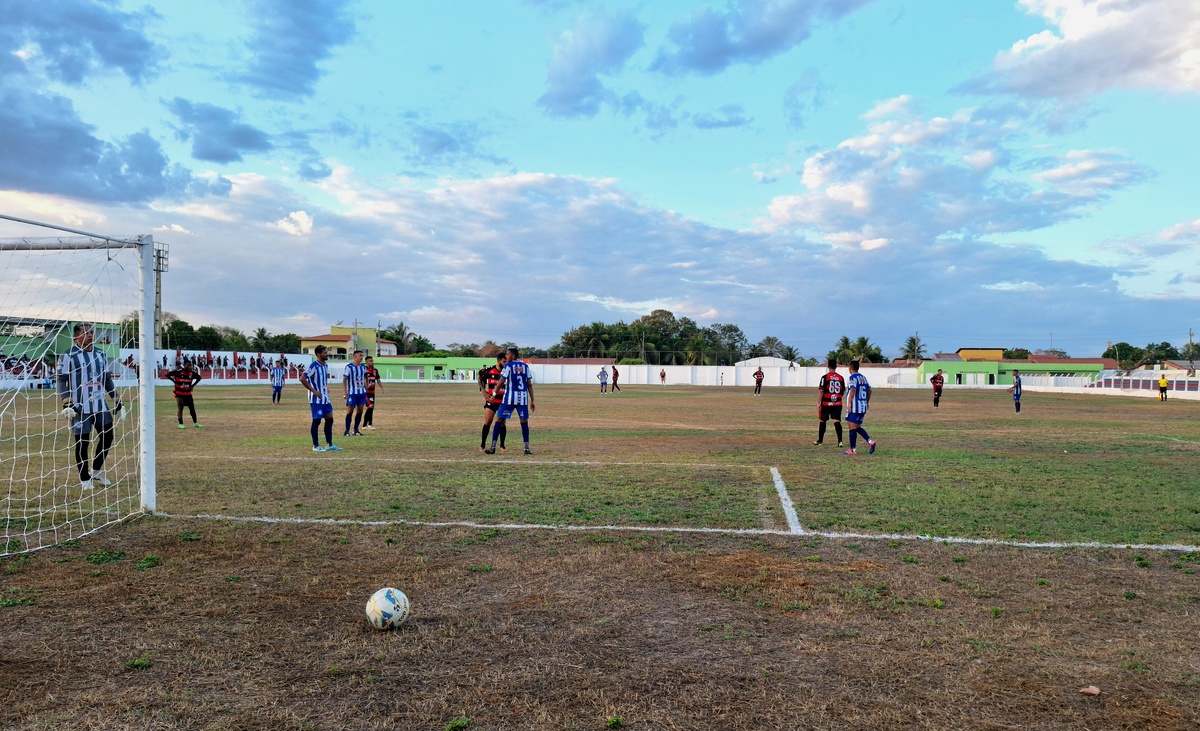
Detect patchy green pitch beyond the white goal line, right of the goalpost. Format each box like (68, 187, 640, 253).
(150, 384, 1200, 544)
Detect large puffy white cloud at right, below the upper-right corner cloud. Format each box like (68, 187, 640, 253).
(761, 97, 1150, 251)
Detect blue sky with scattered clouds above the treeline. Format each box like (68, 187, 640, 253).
(0, 0, 1200, 356)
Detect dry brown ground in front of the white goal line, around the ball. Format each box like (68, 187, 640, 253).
(0, 519, 1200, 730)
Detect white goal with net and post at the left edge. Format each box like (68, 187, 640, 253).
(0, 232, 155, 556)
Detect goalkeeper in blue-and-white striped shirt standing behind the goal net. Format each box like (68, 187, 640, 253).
(59, 323, 124, 491)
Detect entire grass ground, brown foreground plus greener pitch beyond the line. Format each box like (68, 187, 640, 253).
(0, 384, 1200, 730)
